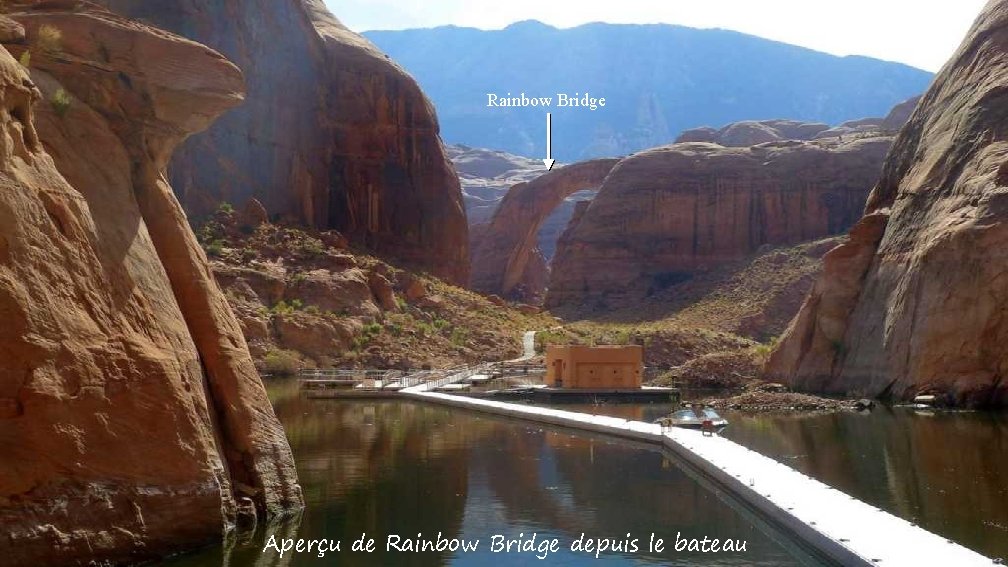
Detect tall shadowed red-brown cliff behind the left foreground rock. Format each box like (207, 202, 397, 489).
(96, 0, 469, 282)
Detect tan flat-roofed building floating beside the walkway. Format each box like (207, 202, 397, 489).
(546, 345, 644, 389)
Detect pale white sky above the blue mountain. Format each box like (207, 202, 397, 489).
(326, 0, 987, 71)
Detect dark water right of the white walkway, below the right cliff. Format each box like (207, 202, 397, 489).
(548, 405, 1008, 561)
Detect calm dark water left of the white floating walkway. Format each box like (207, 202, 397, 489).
(155, 381, 821, 567)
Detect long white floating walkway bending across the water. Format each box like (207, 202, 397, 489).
(403, 387, 995, 567)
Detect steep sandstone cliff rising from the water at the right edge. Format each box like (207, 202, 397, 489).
(767, 0, 1008, 406)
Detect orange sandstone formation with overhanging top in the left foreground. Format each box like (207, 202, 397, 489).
(0, 0, 301, 565)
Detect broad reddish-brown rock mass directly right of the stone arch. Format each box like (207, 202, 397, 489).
(546, 137, 891, 309)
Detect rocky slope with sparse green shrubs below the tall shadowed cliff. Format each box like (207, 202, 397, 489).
(195, 214, 555, 367)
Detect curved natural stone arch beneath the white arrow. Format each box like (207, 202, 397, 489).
(471, 159, 619, 297)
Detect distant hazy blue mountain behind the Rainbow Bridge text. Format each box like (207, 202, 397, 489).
(364, 21, 932, 161)
